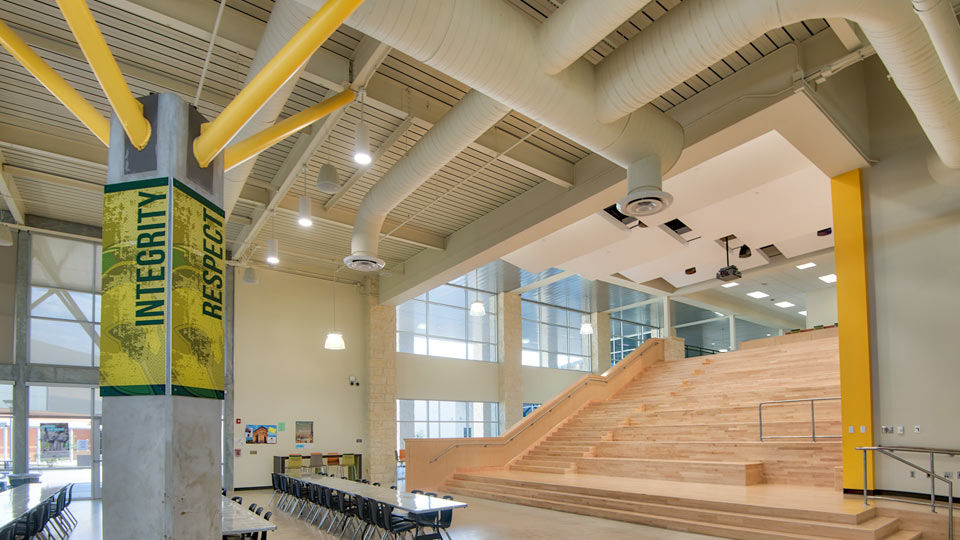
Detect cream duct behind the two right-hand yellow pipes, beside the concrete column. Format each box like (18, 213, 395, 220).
(223, 0, 323, 215)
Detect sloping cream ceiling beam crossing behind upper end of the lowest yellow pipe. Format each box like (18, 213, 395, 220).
(231, 36, 390, 260)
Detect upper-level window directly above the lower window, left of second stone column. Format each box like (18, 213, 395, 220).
(397, 284, 497, 362)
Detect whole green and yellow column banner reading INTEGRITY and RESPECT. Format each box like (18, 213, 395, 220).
(100, 178, 225, 399)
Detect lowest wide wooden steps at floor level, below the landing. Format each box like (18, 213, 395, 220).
(444, 474, 920, 540)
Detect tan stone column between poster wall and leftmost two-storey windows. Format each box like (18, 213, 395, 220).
(363, 295, 397, 485)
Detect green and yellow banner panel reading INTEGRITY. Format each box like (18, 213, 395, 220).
(100, 178, 168, 396)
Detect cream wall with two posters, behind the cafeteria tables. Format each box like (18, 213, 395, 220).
(232, 269, 367, 487)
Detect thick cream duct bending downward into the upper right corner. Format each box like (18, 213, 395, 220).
(596, 0, 960, 168)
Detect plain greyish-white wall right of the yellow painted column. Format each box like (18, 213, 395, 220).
(864, 59, 960, 493)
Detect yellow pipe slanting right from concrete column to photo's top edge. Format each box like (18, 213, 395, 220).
(194, 0, 363, 167)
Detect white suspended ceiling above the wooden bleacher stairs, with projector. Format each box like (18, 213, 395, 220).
(504, 131, 833, 288)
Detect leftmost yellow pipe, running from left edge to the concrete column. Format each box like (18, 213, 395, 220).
(0, 21, 110, 146)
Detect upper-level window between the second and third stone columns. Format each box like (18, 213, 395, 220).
(520, 300, 591, 371)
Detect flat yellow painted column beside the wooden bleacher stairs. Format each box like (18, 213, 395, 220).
(830, 169, 874, 490)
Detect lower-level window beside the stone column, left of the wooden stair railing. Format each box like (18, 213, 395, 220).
(397, 399, 500, 448)
